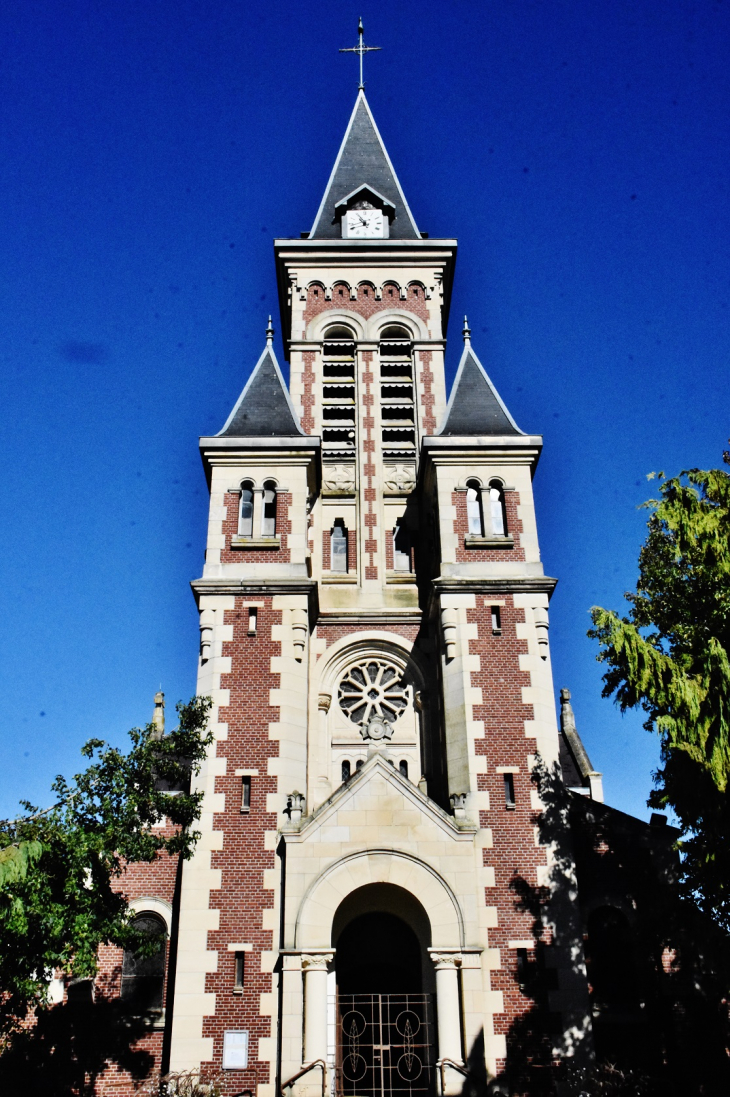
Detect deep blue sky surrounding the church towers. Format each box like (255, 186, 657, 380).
(0, 0, 730, 817)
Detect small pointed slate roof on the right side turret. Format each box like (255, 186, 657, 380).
(437, 343, 525, 438)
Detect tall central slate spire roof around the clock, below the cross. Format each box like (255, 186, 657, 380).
(310, 91, 420, 240)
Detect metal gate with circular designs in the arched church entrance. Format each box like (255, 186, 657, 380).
(337, 994, 436, 1097)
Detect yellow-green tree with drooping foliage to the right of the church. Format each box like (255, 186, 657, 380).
(588, 453, 730, 929)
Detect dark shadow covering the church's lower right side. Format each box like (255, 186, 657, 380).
(462, 766, 730, 1097)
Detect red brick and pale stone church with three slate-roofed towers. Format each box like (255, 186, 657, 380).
(78, 42, 702, 1097)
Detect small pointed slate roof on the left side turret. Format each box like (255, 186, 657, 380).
(215, 343, 304, 438)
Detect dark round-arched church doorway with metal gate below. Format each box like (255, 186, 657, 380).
(332, 883, 436, 1097)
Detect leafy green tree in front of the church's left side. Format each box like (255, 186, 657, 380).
(0, 698, 211, 1031)
